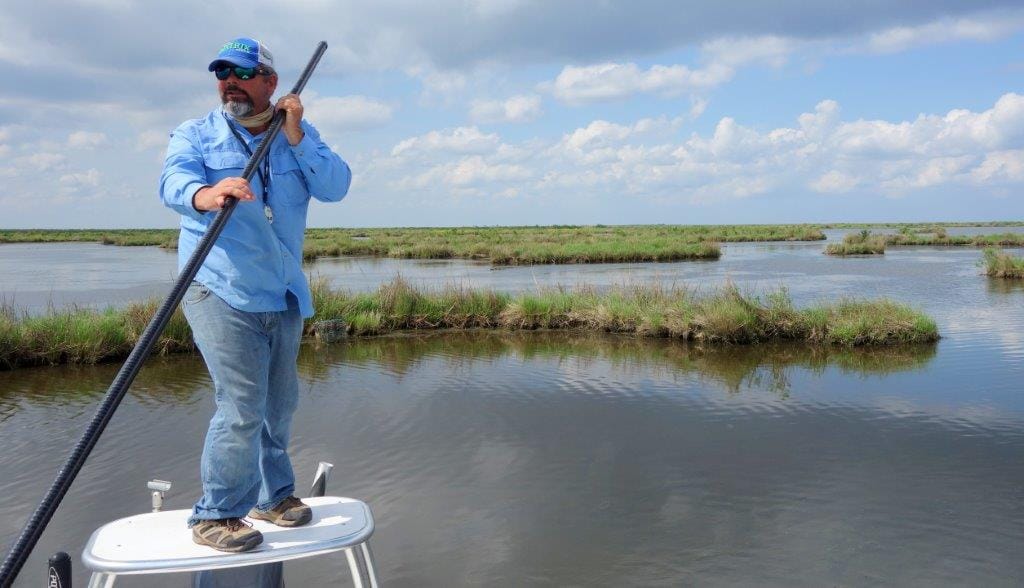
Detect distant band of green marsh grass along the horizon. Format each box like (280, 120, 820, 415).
(0, 222, 1024, 265)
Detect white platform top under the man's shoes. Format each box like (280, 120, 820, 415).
(82, 496, 374, 576)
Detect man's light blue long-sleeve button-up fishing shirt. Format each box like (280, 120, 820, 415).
(160, 108, 352, 317)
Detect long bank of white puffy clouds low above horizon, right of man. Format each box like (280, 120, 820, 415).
(368, 93, 1024, 205)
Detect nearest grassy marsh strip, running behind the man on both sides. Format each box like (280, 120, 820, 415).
(0, 279, 939, 369)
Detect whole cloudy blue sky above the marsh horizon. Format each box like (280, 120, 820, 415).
(0, 0, 1024, 228)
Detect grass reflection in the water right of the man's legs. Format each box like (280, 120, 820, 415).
(319, 332, 937, 395)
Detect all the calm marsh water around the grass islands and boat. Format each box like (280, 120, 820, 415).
(0, 232, 1024, 586)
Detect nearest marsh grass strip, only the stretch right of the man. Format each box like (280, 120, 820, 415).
(305, 279, 938, 346)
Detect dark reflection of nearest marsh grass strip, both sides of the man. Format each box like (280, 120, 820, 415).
(0, 331, 936, 422)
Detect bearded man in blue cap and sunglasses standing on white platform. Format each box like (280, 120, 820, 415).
(160, 38, 351, 551)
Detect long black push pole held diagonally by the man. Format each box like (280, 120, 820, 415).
(0, 41, 327, 588)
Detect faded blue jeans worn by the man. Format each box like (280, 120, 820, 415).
(181, 282, 302, 527)
